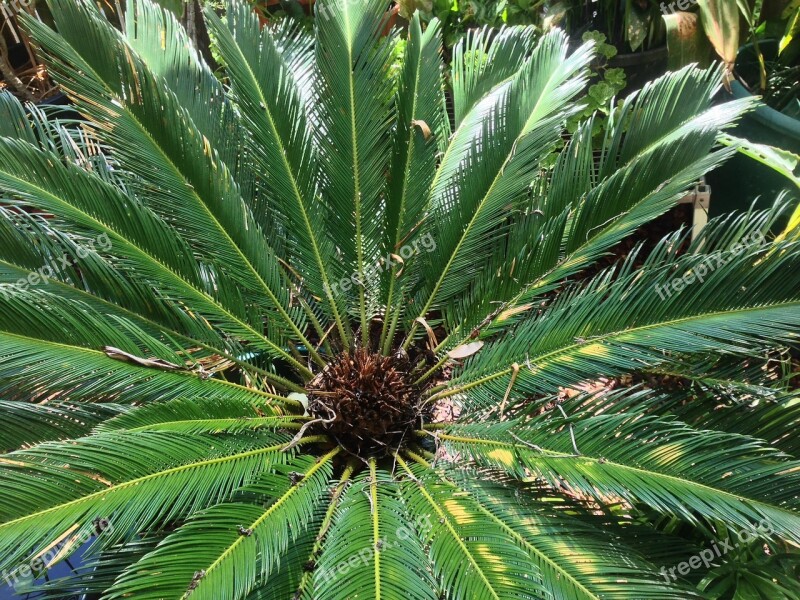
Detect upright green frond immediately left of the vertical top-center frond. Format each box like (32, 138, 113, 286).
(209, 4, 345, 334)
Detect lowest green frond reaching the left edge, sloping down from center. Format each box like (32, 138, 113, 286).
(0, 432, 298, 569)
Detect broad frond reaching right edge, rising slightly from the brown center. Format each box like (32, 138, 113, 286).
(439, 234, 800, 403)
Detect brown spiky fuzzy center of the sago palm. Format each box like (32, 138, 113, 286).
(307, 349, 422, 456)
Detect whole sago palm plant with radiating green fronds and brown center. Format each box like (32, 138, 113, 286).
(0, 0, 800, 600)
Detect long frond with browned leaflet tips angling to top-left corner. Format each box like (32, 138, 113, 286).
(28, 3, 316, 360)
